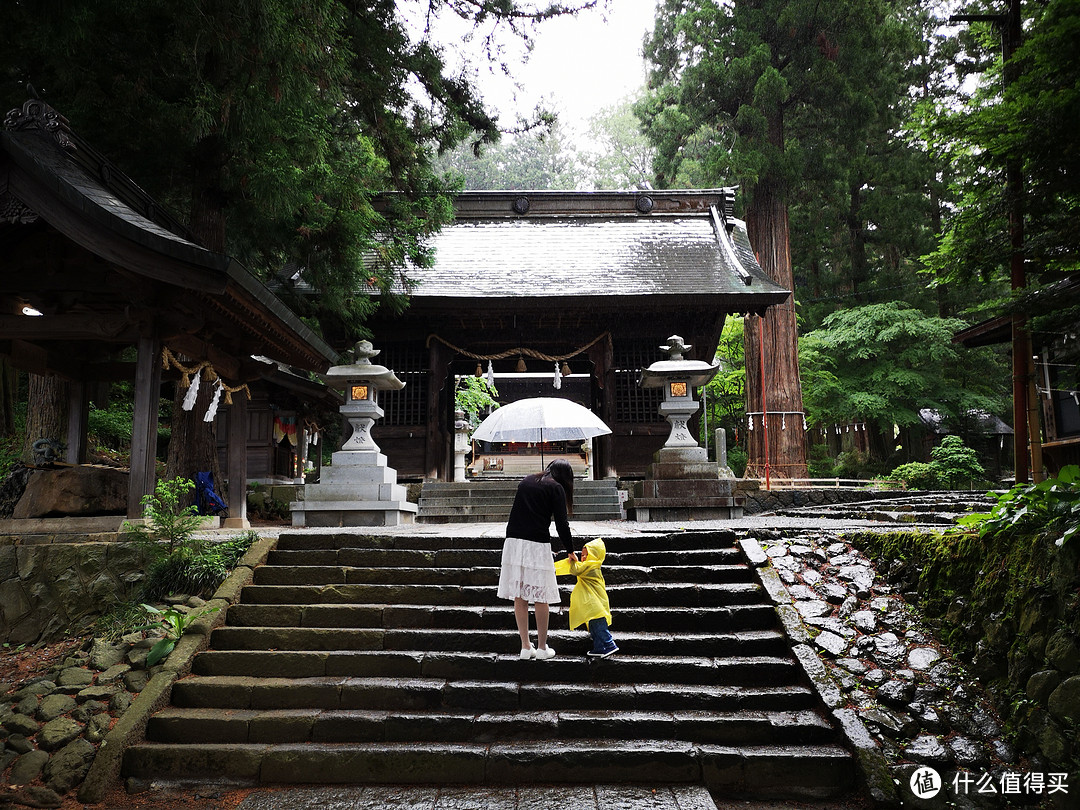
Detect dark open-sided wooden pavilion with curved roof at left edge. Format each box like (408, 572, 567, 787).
(0, 99, 336, 519)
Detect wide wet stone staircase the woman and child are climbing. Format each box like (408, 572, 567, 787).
(123, 530, 856, 798)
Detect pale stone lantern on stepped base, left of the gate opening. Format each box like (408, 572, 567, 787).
(289, 340, 417, 526)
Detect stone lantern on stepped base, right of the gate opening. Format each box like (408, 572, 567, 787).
(626, 335, 742, 522)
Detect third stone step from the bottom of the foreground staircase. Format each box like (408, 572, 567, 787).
(173, 662, 816, 712)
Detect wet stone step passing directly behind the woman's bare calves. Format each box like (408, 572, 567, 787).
(226, 603, 777, 633)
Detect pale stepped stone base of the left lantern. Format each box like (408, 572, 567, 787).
(289, 450, 417, 527)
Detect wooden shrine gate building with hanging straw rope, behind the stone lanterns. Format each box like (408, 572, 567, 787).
(370, 189, 791, 481)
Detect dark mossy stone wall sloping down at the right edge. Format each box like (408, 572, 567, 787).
(851, 532, 1080, 781)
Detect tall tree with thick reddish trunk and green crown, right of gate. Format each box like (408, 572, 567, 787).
(638, 0, 924, 477)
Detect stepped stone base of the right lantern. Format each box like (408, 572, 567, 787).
(626, 447, 743, 523)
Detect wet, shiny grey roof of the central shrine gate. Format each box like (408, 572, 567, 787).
(401, 189, 789, 312)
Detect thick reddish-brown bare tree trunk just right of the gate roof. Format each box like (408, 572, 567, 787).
(743, 181, 807, 478)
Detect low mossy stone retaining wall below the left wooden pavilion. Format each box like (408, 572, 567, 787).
(0, 537, 146, 645)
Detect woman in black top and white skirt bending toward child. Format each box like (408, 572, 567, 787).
(499, 459, 578, 661)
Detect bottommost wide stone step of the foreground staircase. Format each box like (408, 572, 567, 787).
(124, 740, 854, 797)
